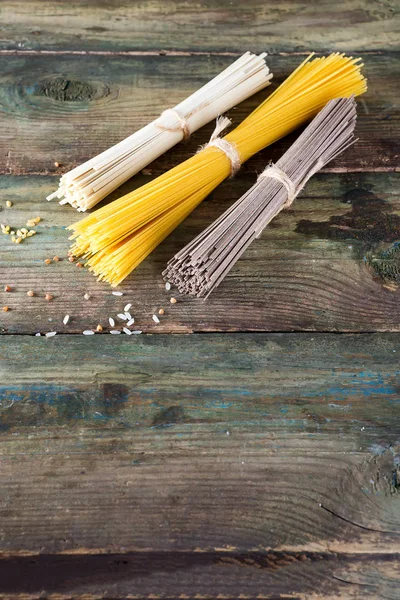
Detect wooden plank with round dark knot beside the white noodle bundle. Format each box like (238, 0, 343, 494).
(0, 54, 399, 175)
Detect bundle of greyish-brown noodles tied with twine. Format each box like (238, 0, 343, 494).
(163, 97, 356, 297)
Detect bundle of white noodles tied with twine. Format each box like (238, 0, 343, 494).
(47, 52, 272, 212)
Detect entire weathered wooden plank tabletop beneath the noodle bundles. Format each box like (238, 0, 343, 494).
(0, 0, 400, 600)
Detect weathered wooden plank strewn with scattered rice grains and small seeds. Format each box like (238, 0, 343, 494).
(0, 174, 400, 333)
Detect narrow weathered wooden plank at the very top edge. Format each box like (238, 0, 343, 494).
(0, 0, 399, 52)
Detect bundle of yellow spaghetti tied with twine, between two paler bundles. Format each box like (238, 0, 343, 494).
(70, 53, 367, 286)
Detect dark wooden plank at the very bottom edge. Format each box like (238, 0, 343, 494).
(0, 552, 400, 600)
